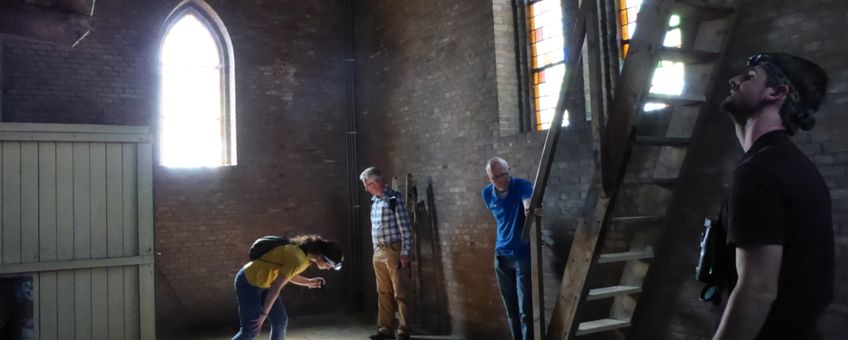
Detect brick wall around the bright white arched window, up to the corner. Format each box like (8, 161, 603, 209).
(2, 0, 348, 337)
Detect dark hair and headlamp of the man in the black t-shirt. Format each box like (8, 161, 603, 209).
(748, 53, 829, 134)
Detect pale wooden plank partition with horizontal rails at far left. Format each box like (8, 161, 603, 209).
(0, 124, 155, 340)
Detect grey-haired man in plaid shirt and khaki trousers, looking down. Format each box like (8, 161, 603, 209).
(359, 167, 412, 340)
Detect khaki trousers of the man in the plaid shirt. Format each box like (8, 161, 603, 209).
(373, 242, 409, 334)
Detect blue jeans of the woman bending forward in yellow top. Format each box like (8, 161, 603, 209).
(233, 269, 289, 340)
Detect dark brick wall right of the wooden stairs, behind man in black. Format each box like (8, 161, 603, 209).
(631, 0, 848, 339)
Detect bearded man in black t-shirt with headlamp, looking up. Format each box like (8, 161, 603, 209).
(713, 53, 834, 340)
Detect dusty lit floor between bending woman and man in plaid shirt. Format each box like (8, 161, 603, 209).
(187, 314, 463, 340)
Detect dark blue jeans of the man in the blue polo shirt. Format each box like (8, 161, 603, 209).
(495, 252, 533, 340)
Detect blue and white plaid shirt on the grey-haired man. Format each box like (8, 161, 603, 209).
(371, 188, 412, 256)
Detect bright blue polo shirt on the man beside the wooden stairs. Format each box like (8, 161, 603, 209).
(481, 177, 533, 256)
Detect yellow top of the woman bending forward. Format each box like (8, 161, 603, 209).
(244, 244, 309, 289)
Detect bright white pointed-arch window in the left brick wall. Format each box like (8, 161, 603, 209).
(159, 0, 236, 167)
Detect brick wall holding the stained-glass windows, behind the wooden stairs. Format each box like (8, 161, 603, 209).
(356, 0, 848, 339)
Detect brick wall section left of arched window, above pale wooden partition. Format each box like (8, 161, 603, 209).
(2, 1, 168, 125)
